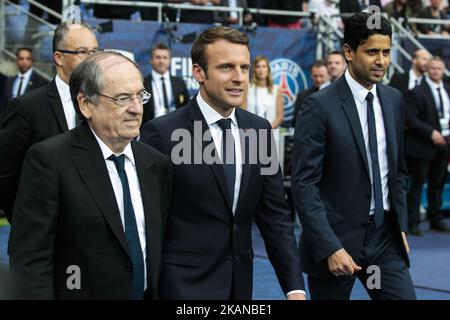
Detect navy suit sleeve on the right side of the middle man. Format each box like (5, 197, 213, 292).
(255, 122, 305, 294)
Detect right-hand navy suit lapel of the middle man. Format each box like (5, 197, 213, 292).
(235, 108, 251, 215)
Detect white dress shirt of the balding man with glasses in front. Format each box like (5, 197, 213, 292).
(91, 128, 147, 290)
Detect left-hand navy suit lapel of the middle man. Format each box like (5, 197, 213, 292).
(188, 96, 233, 211)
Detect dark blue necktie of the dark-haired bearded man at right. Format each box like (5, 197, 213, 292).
(366, 92, 384, 228)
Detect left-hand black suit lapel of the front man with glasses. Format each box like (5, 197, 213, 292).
(71, 122, 128, 254)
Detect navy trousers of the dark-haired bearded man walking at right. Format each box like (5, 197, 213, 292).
(308, 214, 416, 300)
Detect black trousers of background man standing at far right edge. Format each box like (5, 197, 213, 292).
(406, 147, 449, 226)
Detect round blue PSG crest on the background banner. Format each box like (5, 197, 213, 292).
(270, 58, 308, 121)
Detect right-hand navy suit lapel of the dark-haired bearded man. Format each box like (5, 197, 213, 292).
(377, 85, 403, 176)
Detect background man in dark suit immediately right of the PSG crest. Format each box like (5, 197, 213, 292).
(292, 60, 330, 127)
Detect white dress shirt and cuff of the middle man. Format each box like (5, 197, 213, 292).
(197, 93, 306, 295)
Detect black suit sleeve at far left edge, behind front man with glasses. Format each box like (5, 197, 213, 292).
(0, 99, 31, 222)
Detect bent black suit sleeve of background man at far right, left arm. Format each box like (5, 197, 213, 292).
(406, 88, 434, 143)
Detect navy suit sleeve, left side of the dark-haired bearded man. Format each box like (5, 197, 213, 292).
(292, 97, 343, 263)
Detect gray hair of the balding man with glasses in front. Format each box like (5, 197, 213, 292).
(69, 51, 142, 117)
